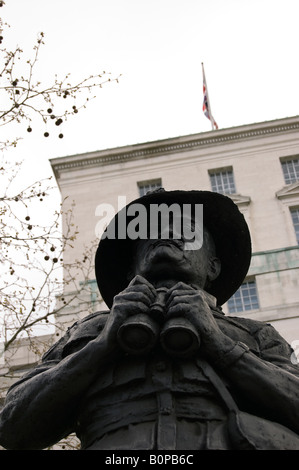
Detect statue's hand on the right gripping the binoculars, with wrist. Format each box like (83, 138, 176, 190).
(165, 282, 225, 355)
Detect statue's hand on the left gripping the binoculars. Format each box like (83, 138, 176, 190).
(103, 275, 157, 343)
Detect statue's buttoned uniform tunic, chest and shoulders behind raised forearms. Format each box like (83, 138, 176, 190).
(6, 298, 299, 450)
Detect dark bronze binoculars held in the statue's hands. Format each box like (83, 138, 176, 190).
(118, 287, 200, 357)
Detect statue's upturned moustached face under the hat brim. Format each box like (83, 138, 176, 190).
(133, 220, 220, 289)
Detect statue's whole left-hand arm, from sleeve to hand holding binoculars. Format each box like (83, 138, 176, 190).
(0, 276, 155, 449)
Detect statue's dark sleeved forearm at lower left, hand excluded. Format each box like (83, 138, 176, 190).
(0, 320, 115, 449)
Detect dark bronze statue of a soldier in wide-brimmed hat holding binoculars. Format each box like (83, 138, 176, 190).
(0, 190, 299, 450)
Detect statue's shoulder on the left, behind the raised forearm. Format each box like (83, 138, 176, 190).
(42, 311, 109, 362)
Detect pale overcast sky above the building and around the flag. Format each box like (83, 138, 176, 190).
(0, 0, 299, 187)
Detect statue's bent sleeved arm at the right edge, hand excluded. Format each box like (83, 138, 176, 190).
(211, 325, 299, 433)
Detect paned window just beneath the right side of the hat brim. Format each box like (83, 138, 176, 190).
(227, 280, 259, 313)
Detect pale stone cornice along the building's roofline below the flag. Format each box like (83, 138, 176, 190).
(50, 116, 299, 177)
